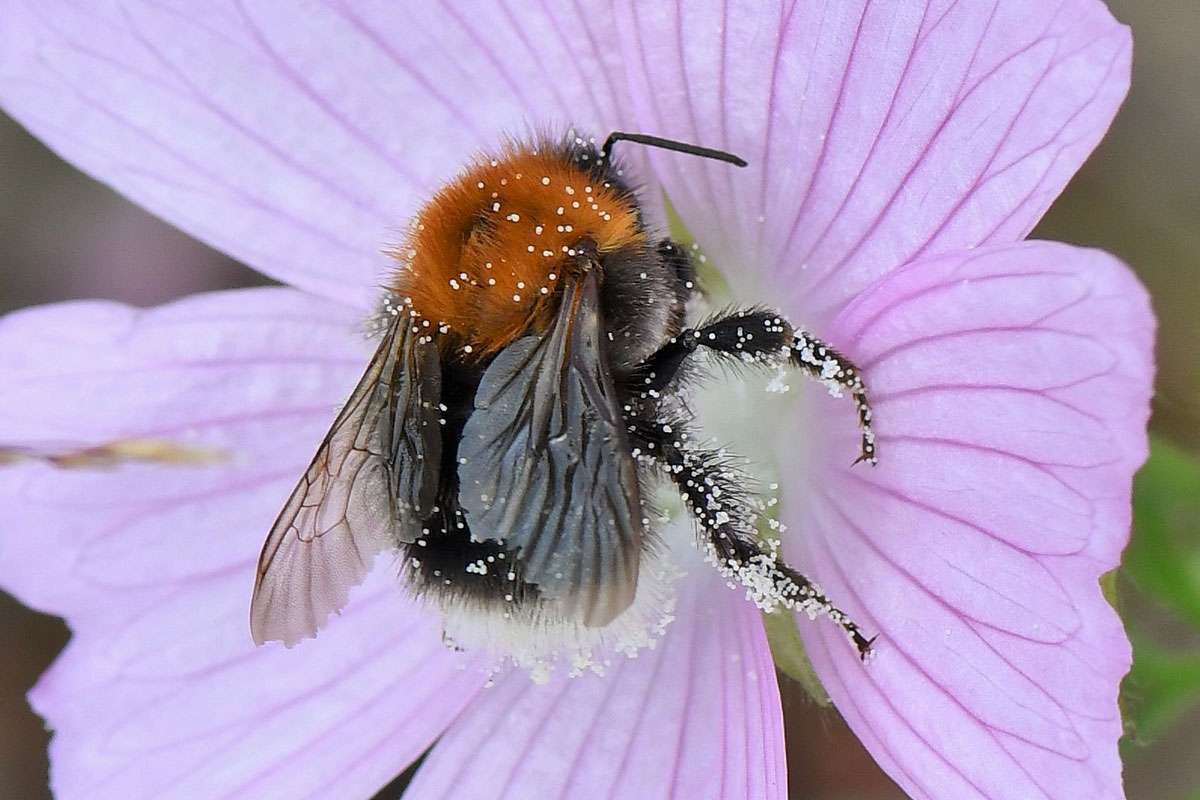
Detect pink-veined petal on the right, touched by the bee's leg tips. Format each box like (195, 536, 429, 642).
(787, 242, 1153, 800)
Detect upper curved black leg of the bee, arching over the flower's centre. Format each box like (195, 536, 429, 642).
(629, 308, 877, 464)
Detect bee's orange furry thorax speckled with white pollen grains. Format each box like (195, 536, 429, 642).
(391, 149, 646, 355)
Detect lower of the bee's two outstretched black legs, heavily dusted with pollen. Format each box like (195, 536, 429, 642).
(629, 417, 875, 661)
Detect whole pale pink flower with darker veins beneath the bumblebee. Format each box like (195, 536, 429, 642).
(0, 0, 1153, 800)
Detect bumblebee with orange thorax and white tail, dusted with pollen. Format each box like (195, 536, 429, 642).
(251, 133, 876, 656)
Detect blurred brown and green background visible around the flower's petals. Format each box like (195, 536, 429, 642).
(0, 0, 1200, 800)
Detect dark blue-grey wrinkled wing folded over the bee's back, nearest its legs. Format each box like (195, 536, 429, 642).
(458, 271, 644, 626)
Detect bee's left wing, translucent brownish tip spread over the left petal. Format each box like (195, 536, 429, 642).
(250, 315, 442, 645)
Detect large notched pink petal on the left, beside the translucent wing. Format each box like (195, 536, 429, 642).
(0, 289, 484, 798)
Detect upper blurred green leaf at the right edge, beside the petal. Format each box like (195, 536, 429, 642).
(1124, 439, 1200, 628)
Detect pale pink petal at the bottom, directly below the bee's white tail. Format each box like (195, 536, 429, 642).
(404, 559, 787, 800)
